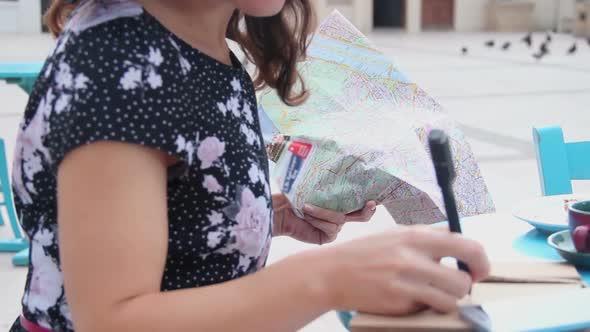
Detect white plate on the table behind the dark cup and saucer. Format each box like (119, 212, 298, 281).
(513, 194, 590, 233)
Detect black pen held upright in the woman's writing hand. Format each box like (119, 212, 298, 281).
(428, 129, 469, 273)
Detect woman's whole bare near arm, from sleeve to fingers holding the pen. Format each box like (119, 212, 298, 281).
(58, 142, 489, 332)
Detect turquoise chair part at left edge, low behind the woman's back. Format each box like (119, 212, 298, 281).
(0, 138, 28, 252)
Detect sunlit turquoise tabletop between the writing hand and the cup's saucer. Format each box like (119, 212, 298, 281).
(350, 213, 590, 332)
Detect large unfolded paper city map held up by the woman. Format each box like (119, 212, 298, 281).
(260, 12, 495, 224)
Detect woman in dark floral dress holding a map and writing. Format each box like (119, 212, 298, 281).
(11, 0, 488, 331)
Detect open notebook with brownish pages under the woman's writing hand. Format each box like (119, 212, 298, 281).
(350, 262, 590, 332)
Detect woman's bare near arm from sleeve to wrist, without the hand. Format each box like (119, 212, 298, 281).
(58, 142, 329, 332)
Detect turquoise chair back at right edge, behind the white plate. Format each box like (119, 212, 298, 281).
(533, 127, 590, 196)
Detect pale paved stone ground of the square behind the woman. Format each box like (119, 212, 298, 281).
(0, 31, 590, 332)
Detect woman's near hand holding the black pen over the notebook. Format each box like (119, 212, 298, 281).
(305, 226, 490, 315)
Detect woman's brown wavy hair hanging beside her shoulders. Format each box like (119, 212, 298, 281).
(44, 0, 315, 106)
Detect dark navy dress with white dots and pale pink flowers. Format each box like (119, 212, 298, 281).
(12, 0, 272, 331)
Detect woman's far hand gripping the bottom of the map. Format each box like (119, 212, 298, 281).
(273, 194, 377, 245)
